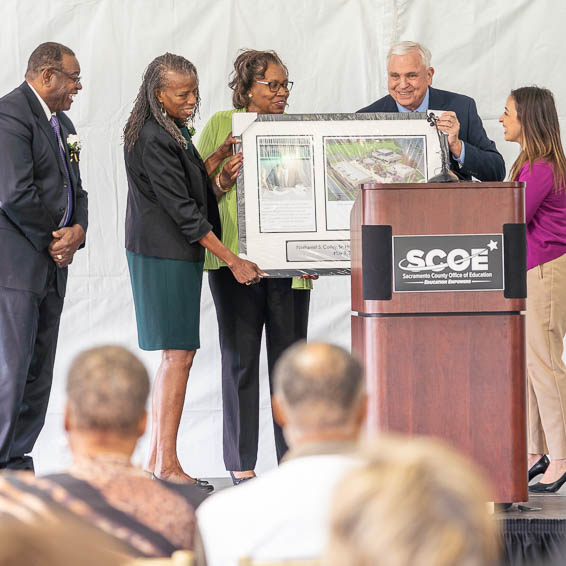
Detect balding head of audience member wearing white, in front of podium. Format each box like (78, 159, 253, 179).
(273, 342, 366, 444)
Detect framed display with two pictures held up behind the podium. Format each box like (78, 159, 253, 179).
(232, 113, 441, 277)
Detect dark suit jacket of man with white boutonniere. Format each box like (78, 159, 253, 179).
(0, 82, 88, 297)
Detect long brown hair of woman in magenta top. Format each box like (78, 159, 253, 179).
(510, 86, 566, 191)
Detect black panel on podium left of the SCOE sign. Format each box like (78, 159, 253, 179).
(362, 225, 393, 301)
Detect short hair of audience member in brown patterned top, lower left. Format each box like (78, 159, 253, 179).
(67, 346, 149, 434)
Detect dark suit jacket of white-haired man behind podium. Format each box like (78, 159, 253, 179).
(358, 87, 505, 181)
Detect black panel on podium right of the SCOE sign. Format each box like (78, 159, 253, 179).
(503, 224, 527, 299)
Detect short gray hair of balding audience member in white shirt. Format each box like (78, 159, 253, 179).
(274, 341, 365, 427)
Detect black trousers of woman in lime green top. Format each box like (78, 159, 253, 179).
(208, 267, 310, 471)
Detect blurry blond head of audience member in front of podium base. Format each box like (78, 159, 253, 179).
(324, 436, 499, 566)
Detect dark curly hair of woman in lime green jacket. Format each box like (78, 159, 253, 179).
(228, 49, 289, 109)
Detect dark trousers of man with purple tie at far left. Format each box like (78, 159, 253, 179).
(0, 266, 63, 470)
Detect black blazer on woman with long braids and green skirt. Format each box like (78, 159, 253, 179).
(124, 117, 220, 261)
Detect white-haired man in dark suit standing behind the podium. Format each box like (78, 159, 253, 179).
(358, 41, 505, 181)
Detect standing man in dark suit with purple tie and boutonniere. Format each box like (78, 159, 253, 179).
(0, 43, 87, 470)
